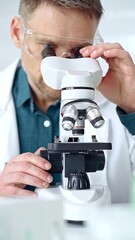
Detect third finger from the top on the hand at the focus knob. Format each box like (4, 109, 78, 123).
(3, 172, 49, 188)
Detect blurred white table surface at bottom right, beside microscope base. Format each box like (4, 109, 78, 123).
(64, 204, 135, 240)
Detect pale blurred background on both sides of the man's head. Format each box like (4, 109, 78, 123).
(0, 0, 135, 70)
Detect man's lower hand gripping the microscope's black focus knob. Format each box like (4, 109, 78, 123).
(0, 148, 53, 196)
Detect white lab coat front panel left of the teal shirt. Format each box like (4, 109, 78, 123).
(0, 61, 19, 171)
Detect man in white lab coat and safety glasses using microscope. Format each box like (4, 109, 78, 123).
(0, 0, 135, 202)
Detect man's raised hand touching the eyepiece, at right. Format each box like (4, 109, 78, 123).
(80, 43, 135, 113)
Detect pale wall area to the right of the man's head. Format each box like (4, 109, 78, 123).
(99, 0, 135, 59)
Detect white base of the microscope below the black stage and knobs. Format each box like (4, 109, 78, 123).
(36, 185, 111, 221)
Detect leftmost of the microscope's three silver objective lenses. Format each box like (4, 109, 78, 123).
(62, 105, 78, 131)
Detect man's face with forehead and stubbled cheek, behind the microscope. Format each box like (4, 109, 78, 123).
(12, 5, 97, 101)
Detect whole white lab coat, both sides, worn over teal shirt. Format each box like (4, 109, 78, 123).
(0, 61, 135, 203)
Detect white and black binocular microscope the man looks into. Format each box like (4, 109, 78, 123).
(38, 47, 112, 221)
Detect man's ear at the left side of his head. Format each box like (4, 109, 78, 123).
(10, 17, 22, 48)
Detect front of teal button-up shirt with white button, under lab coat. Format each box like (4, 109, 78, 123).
(12, 63, 61, 188)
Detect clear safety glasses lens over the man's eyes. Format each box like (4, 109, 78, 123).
(23, 30, 93, 60)
